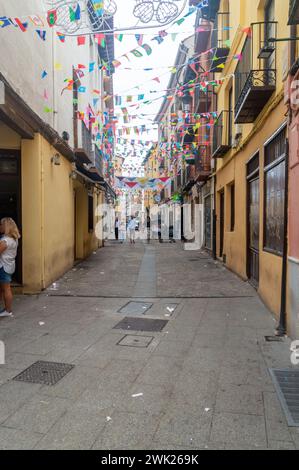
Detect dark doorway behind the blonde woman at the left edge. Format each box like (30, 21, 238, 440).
(0, 149, 22, 284)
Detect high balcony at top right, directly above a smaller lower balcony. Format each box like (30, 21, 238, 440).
(210, 12, 230, 73)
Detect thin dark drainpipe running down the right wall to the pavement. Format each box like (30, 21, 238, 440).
(276, 139, 289, 336)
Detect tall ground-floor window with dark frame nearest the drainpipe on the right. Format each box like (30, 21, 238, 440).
(264, 129, 286, 255)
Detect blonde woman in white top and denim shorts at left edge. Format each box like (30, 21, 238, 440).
(0, 217, 20, 317)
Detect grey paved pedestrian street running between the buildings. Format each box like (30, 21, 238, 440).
(0, 241, 299, 450)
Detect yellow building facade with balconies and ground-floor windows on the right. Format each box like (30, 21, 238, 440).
(212, 0, 290, 317)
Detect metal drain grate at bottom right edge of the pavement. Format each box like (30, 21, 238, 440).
(269, 369, 299, 427)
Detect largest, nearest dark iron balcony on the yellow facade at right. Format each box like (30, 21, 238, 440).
(235, 22, 277, 124)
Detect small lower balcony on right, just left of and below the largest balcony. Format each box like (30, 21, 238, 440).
(212, 111, 232, 158)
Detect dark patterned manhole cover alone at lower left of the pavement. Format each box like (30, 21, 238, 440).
(13, 361, 75, 385)
